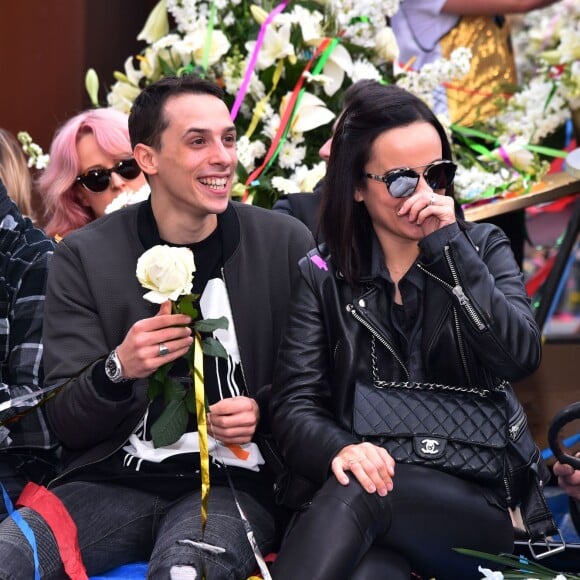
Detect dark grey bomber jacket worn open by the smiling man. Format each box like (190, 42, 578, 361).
(44, 202, 314, 482)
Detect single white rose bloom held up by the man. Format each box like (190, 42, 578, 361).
(137, 246, 195, 304)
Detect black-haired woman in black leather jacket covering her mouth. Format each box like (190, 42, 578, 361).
(271, 83, 541, 580)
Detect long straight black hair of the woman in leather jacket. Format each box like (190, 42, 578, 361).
(320, 81, 452, 285)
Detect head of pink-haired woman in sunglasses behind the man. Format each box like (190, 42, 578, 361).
(38, 109, 146, 238)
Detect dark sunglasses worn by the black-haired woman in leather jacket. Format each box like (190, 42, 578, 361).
(365, 159, 457, 198)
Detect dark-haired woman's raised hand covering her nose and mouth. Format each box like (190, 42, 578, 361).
(398, 191, 456, 236)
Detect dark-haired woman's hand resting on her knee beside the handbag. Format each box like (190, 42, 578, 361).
(331, 443, 395, 496)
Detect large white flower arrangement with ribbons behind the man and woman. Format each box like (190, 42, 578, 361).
(98, 0, 471, 207)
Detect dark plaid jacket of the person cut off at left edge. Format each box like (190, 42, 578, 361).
(0, 181, 55, 450)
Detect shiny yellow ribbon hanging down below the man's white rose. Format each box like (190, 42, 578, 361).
(193, 332, 210, 539)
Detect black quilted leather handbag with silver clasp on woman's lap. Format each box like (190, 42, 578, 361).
(353, 383, 508, 482)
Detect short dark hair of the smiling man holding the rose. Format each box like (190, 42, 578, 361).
(129, 75, 224, 149)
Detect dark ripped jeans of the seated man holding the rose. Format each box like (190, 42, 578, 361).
(0, 482, 276, 580)
